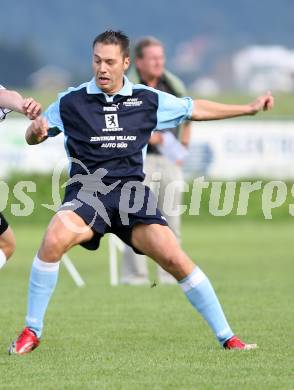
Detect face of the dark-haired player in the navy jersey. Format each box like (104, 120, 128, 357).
(92, 42, 130, 95)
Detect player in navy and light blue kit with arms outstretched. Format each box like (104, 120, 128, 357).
(9, 31, 274, 354)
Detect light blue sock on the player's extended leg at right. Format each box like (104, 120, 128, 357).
(179, 267, 234, 345)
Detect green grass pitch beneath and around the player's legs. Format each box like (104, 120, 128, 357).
(0, 220, 294, 390)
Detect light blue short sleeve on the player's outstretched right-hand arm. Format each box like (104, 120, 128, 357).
(156, 91, 194, 130)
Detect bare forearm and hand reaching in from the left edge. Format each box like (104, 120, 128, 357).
(0, 89, 42, 119)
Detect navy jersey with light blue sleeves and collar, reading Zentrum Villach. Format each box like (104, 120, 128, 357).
(44, 77, 193, 182)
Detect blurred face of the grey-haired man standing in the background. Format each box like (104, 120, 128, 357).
(136, 45, 165, 78)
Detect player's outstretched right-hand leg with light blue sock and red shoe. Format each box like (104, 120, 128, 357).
(132, 224, 255, 349)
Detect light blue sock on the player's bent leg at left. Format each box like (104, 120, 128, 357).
(26, 256, 60, 337)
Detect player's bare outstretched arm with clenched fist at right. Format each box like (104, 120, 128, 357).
(191, 92, 274, 121)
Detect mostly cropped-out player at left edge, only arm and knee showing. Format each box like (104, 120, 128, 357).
(0, 85, 41, 269)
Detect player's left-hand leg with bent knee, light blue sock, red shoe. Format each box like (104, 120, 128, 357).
(9, 211, 94, 354)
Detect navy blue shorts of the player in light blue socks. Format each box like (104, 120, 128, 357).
(59, 182, 168, 254)
